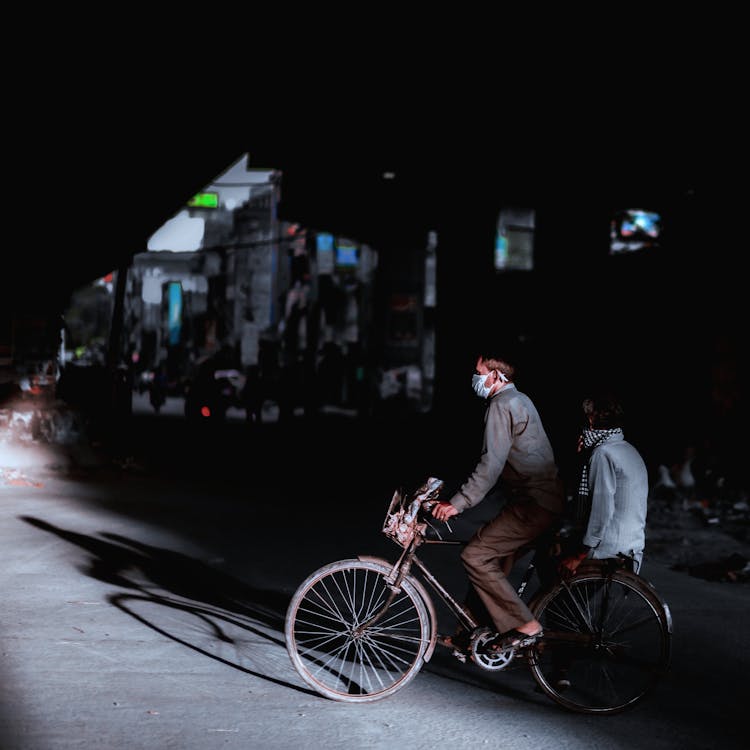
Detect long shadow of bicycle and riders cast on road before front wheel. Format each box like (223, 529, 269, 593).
(20, 516, 318, 696)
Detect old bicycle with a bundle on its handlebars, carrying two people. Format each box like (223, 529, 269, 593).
(285, 477, 672, 714)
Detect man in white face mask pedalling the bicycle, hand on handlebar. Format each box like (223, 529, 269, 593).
(432, 356, 564, 651)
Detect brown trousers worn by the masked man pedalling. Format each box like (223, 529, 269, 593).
(461, 499, 559, 633)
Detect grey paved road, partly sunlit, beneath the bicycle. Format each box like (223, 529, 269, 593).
(0, 420, 750, 750)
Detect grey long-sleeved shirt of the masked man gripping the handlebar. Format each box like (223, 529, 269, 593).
(450, 383, 564, 513)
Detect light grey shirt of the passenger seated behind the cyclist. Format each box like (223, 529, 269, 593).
(583, 435, 648, 567)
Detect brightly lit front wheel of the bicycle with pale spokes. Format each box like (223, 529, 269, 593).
(285, 560, 431, 703)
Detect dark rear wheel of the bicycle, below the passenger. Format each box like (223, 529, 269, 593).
(529, 572, 671, 714)
